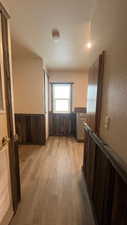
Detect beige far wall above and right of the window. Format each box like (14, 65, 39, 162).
(49, 71, 88, 108)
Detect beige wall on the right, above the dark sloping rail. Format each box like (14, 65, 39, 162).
(91, 0, 127, 162)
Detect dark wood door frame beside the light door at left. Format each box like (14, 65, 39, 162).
(1, 10, 21, 212)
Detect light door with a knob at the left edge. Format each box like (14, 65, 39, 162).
(0, 14, 13, 225)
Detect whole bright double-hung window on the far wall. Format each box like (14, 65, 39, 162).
(53, 83, 72, 113)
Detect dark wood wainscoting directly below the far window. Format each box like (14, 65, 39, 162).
(49, 112, 76, 136)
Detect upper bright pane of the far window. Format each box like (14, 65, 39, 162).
(53, 84, 71, 99)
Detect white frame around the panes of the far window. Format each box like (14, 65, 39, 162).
(52, 83, 72, 114)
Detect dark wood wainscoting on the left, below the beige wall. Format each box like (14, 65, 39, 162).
(15, 114, 46, 145)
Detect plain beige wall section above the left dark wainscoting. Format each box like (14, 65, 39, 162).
(13, 57, 44, 114)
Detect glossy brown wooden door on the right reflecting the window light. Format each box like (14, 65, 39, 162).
(87, 52, 104, 135)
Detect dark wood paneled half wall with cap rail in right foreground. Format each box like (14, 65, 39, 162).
(83, 124, 127, 225)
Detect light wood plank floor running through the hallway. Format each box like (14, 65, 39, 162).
(11, 137, 94, 225)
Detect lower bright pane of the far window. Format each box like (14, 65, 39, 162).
(54, 100, 70, 112)
